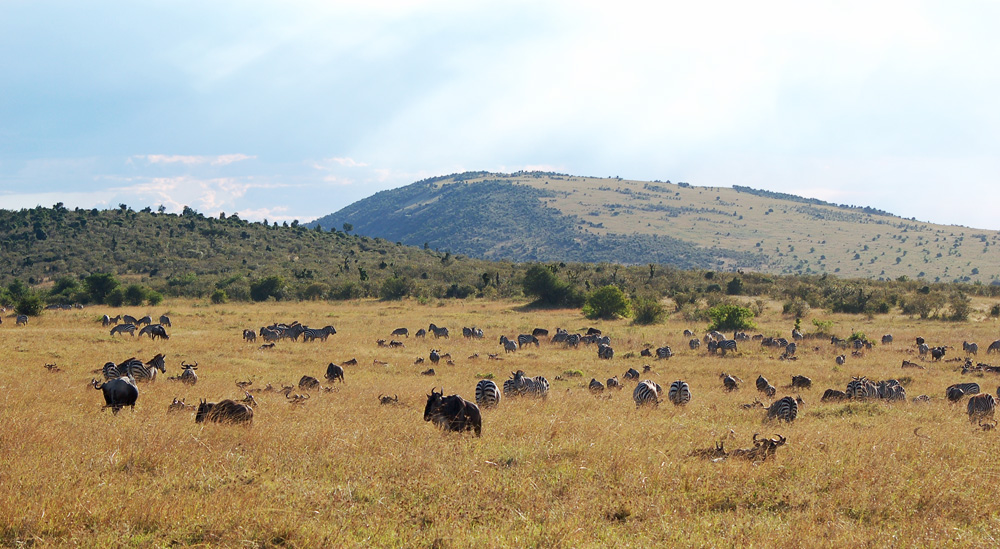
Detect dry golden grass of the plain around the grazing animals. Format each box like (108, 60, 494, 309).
(0, 301, 1000, 547)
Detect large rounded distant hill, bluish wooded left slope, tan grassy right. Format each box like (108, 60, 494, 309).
(310, 172, 1000, 283)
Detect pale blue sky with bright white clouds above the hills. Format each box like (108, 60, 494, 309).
(0, 0, 1000, 230)
